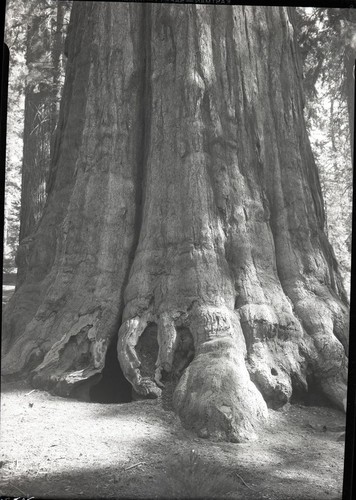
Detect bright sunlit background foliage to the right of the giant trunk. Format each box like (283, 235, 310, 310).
(296, 8, 356, 294)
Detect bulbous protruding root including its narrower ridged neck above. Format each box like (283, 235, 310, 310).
(173, 306, 267, 442)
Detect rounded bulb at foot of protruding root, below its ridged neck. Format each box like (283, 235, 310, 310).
(173, 339, 268, 443)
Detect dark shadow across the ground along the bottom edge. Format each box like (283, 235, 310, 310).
(1, 450, 341, 500)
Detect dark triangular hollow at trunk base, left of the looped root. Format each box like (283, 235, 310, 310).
(89, 335, 132, 404)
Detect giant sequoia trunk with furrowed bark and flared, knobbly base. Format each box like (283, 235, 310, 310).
(3, 2, 348, 441)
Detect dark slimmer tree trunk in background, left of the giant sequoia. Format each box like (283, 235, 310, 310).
(16, 1, 69, 286)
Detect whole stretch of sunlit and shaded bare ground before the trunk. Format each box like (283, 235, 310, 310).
(0, 383, 344, 500)
